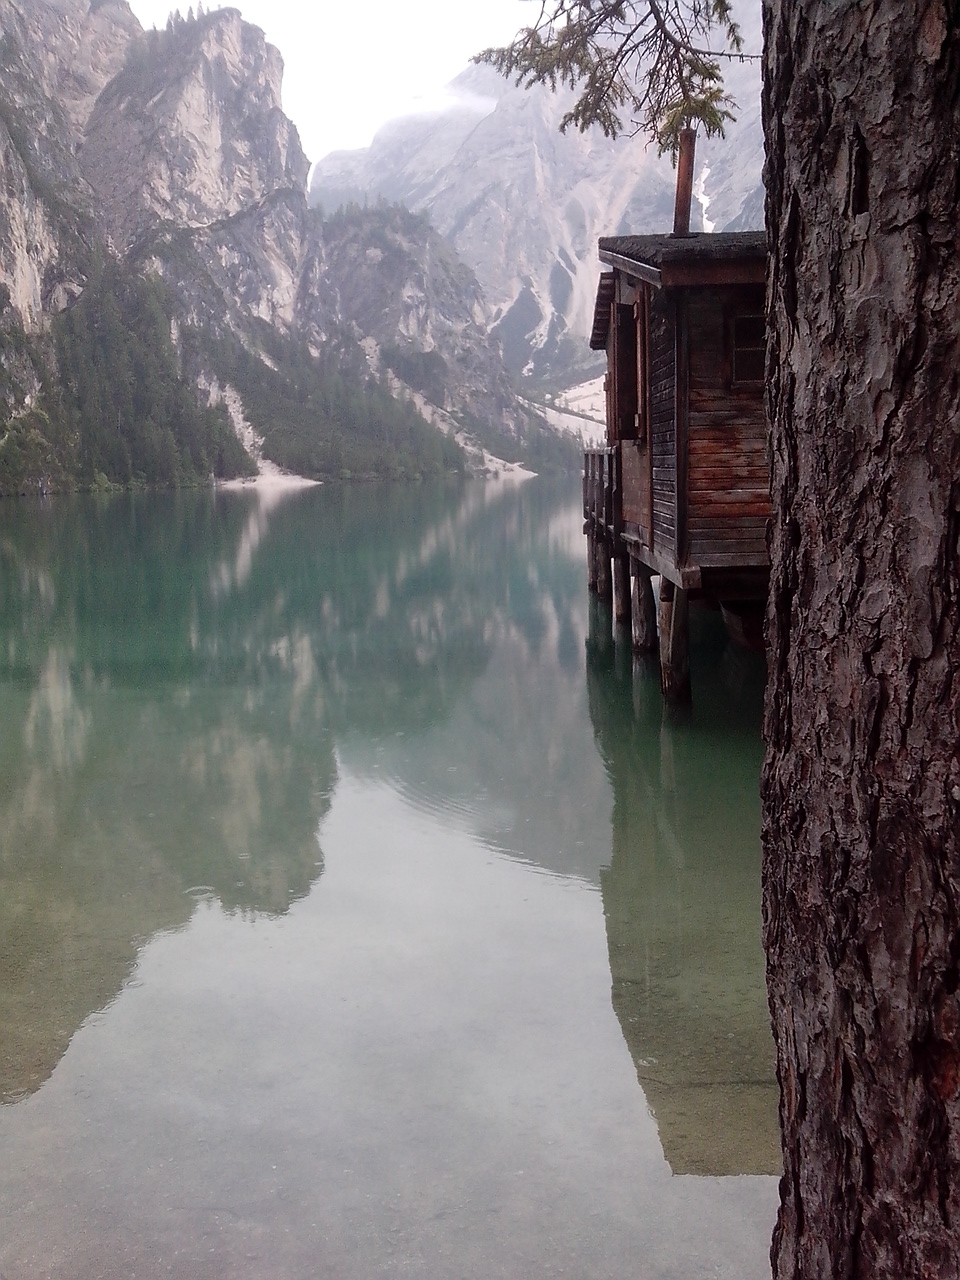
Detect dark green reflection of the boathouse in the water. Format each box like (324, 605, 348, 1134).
(588, 604, 781, 1175)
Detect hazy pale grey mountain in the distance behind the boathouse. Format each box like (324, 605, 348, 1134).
(310, 27, 763, 385)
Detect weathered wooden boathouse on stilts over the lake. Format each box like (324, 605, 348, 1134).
(584, 232, 771, 699)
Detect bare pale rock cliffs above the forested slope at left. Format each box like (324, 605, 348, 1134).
(0, 0, 555, 481)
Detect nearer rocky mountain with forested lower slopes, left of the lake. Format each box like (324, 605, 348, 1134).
(0, 0, 573, 492)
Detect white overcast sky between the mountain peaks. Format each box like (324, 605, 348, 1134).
(131, 0, 540, 161)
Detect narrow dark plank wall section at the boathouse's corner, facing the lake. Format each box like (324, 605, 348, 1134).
(649, 289, 677, 556)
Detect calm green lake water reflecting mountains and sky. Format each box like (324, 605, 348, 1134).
(0, 480, 778, 1280)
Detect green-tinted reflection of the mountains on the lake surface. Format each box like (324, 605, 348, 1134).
(0, 485, 600, 1101)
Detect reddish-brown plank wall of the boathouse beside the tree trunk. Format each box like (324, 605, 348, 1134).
(686, 288, 771, 567)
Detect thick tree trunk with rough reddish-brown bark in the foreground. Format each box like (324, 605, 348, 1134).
(763, 0, 960, 1280)
